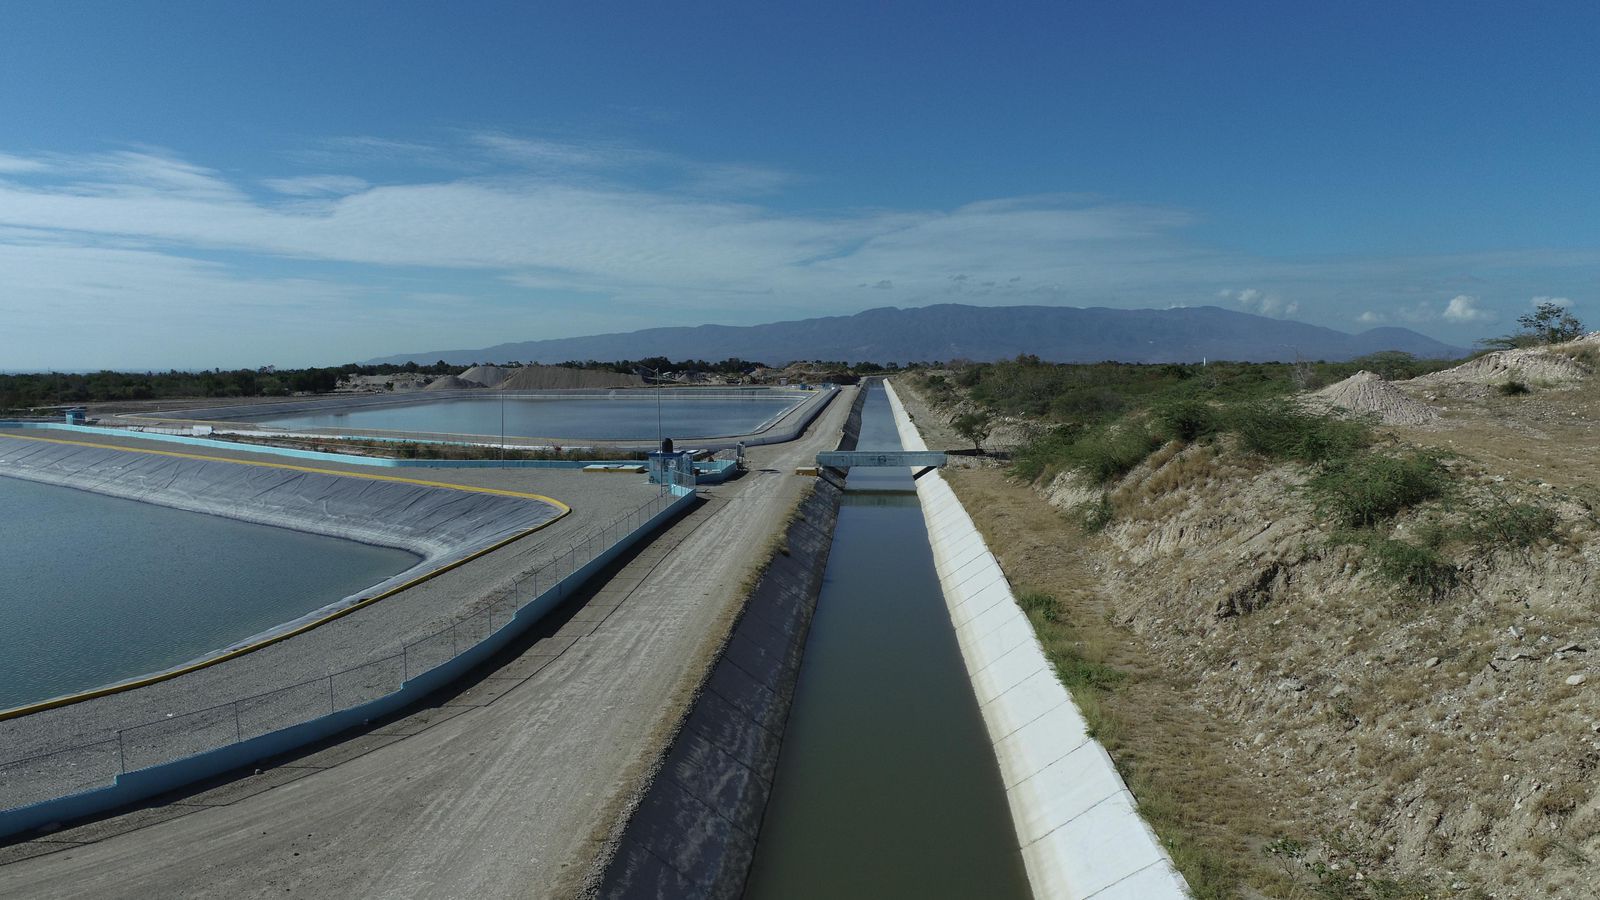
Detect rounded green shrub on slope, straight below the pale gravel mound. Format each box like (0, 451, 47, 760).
(1306, 452, 1450, 528)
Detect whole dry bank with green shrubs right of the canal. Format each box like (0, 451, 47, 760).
(901, 338, 1600, 898)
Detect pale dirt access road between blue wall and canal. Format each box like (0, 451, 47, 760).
(0, 381, 854, 900)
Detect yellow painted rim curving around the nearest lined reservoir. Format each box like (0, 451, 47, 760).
(0, 434, 573, 722)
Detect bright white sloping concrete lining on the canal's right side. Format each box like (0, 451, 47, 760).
(885, 384, 1189, 900)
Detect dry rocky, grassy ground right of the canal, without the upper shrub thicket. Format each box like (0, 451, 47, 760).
(901, 358, 1600, 898)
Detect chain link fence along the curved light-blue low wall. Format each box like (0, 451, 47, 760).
(0, 483, 694, 810)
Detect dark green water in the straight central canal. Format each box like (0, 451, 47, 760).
(746, 388, 1029, 900)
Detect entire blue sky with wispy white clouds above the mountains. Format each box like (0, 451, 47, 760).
(0, 0, 1600, 370)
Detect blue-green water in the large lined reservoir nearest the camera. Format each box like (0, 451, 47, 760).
(0, 477, 418, 709)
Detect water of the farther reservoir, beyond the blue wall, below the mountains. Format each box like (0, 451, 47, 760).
(250, 391, 797, 440)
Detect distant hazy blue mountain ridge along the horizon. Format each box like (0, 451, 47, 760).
(368, 303, 1467, 365)
